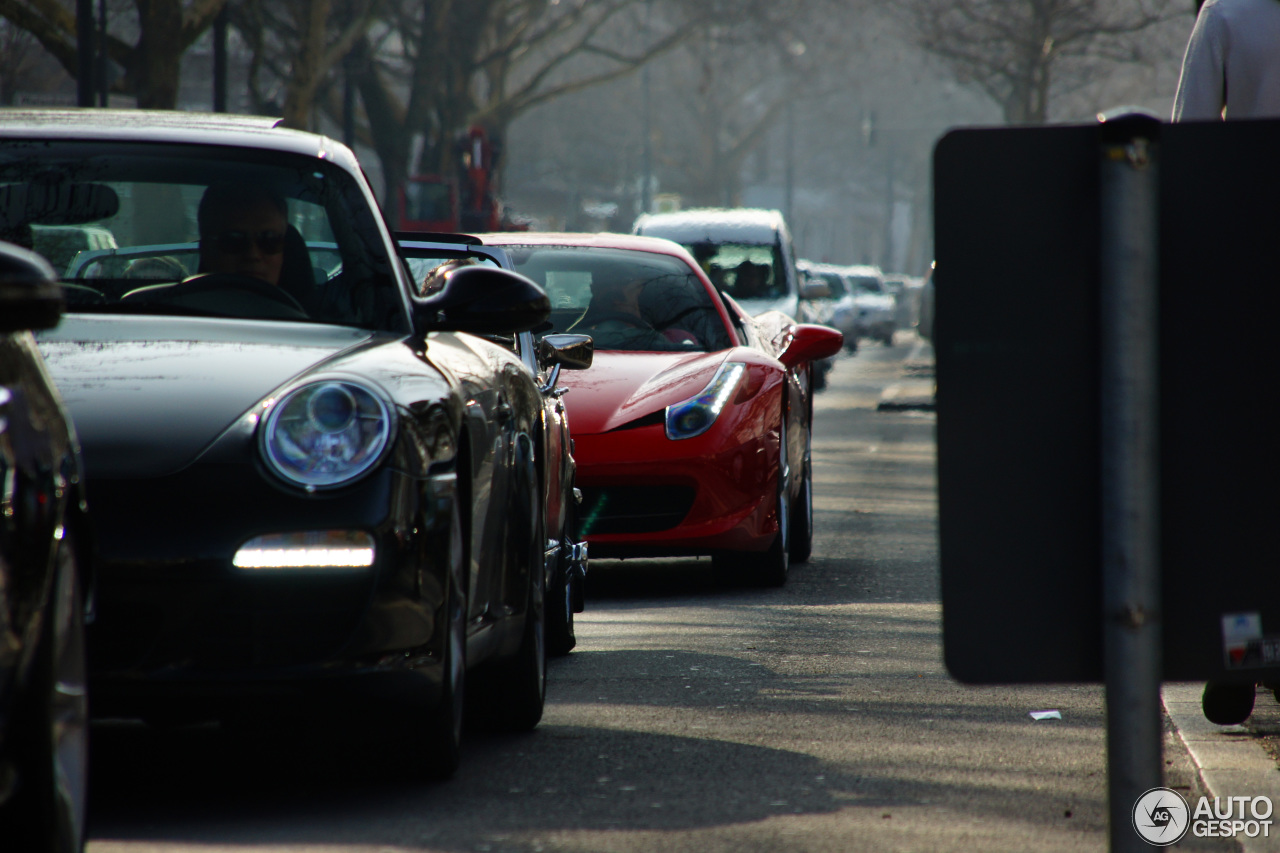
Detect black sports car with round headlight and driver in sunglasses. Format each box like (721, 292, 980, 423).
(0, 110, 586, 774)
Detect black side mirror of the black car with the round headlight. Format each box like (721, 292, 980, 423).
(413, 266, 552, 334)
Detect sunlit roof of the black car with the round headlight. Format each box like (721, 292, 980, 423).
(0, 109, 358, 169)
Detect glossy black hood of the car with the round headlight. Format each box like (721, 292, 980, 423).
(38, 315, 374, 478)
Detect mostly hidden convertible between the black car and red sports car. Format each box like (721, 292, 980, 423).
(398, 232, 593, 656)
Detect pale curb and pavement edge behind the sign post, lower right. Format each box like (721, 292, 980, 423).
(1160, 681, 1280, 853)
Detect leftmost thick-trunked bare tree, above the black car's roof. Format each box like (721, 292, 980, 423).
(0, 0, 227, 109)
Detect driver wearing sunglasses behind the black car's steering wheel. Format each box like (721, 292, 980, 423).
(196, 183, 288, 284)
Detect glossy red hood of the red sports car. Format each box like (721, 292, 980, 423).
(559, 351, 730, 435)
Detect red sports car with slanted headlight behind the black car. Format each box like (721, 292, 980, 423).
(480, 233, 842, 585)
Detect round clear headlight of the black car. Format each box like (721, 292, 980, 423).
(261, 380, 392, 491)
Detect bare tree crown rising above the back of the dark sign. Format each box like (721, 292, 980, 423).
(896, 0, 1185, 124)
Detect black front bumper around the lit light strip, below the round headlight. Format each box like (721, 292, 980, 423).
(88, 465, 453, 716)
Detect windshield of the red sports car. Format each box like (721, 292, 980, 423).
(507, 246, 732, 352)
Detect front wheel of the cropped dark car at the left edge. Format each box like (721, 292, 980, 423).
(0, 537, 88, 853)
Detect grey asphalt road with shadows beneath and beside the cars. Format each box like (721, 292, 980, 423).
(88, 334, 1234, 853)
